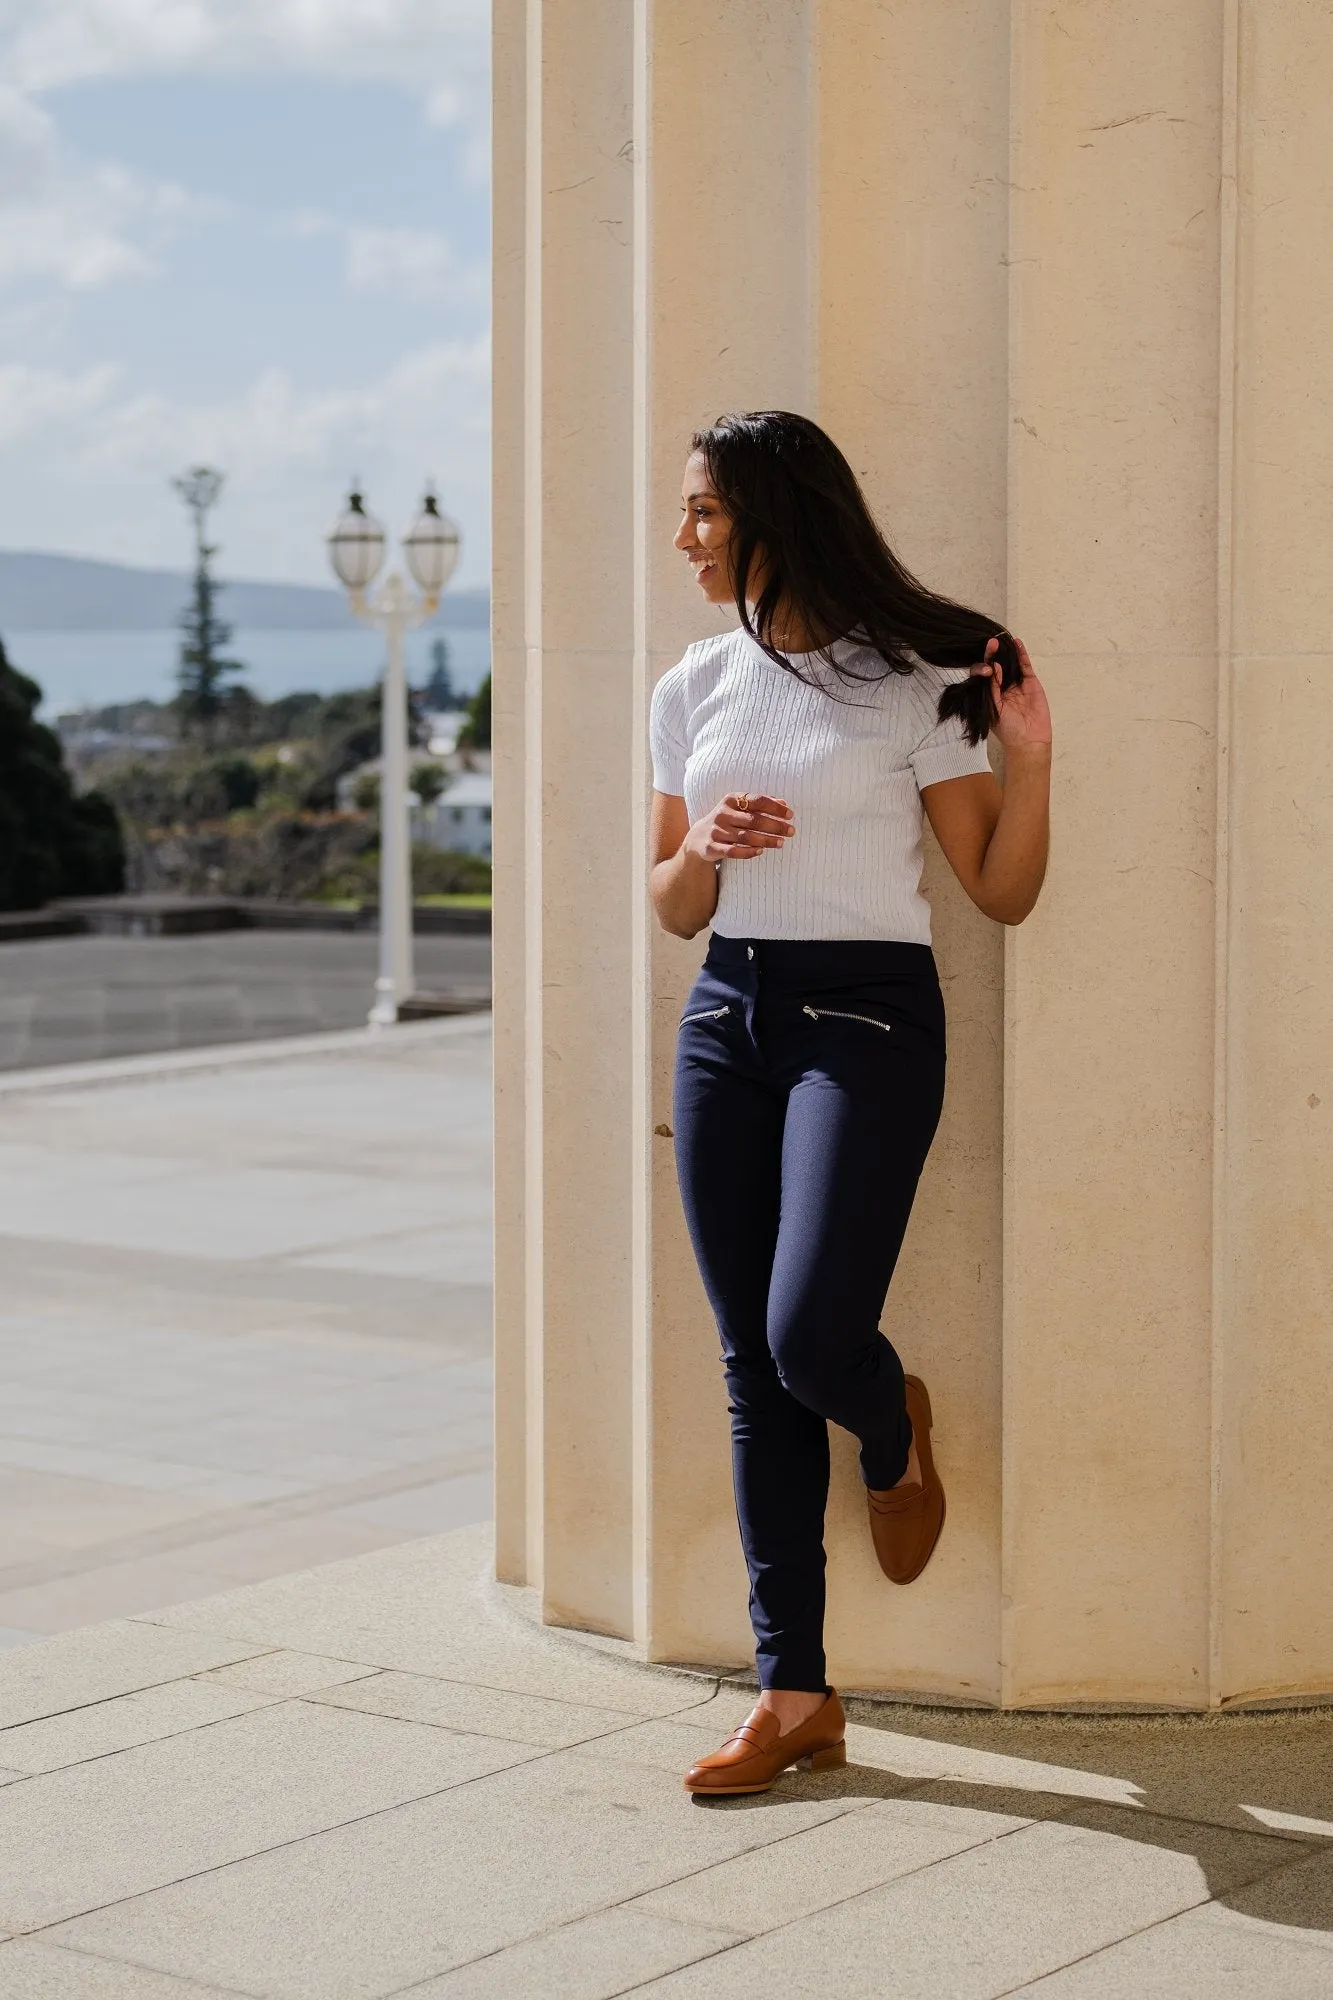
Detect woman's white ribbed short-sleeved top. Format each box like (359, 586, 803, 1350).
(650, 632, 991, 944)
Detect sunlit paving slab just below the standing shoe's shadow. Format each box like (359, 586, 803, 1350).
(632, 1798, 1031, 1936)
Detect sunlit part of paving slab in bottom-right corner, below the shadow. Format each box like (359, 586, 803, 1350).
(1019, 1904, 1333, 2000)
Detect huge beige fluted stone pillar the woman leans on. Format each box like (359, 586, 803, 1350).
(496, 0, 1333, 1706)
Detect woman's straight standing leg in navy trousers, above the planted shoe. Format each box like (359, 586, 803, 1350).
(675, 1028, 829, 1692)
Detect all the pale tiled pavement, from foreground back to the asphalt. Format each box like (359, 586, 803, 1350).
(0, 1018, 1333, 2000)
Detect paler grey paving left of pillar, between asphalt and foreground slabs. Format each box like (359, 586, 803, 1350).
(0, 1024, 490, 1648)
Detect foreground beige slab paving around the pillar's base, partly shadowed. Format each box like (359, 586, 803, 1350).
(0, 1528, 1333, 2000)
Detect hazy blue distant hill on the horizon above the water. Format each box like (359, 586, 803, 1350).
(0, 550, 490, 634)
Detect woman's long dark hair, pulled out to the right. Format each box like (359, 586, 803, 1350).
(691, 410, 1023, 744)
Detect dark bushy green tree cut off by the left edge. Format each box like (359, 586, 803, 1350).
(0, 642, 124, 910)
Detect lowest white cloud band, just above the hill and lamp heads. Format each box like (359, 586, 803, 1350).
(0, 340, 488, 582)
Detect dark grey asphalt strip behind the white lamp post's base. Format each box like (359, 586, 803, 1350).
(0, 930, 490, 1070)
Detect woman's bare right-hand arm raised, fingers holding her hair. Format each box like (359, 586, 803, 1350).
(921, 642, 1051, 924)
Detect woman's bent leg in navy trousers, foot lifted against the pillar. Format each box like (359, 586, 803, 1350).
(769, 1028, 945, 1488)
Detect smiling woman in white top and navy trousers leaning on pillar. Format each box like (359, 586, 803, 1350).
(650, 410, 1051, 1792)
